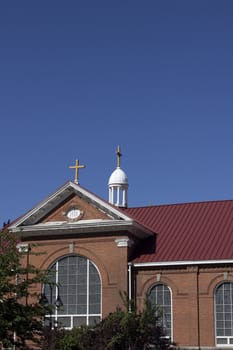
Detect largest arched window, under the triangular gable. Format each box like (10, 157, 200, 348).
(43, 255, 101, 328)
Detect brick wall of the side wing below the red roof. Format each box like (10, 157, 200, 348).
(134, 266, 233, 348)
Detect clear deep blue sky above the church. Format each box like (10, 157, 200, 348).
(0, 0, 233, 225)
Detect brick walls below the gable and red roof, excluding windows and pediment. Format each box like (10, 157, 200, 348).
(20, 234, 233, 348)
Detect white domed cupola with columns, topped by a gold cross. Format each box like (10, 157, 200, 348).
(108, 146, 129, 208)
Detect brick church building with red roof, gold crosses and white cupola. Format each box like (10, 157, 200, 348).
(9, 147, 233, 349)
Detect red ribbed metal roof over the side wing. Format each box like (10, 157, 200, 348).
(125, 200, 233, 263)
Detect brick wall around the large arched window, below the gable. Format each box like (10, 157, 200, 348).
(24, 232, 128, 317)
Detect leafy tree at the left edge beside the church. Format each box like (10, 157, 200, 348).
(0, 230, 46, 349)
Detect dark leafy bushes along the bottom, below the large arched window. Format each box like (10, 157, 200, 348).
(43, 302, 171, 350)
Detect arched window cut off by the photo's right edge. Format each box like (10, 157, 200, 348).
(215, 282, 233, 346)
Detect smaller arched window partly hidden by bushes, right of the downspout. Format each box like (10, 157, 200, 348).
(148, 284, 172, 338)
